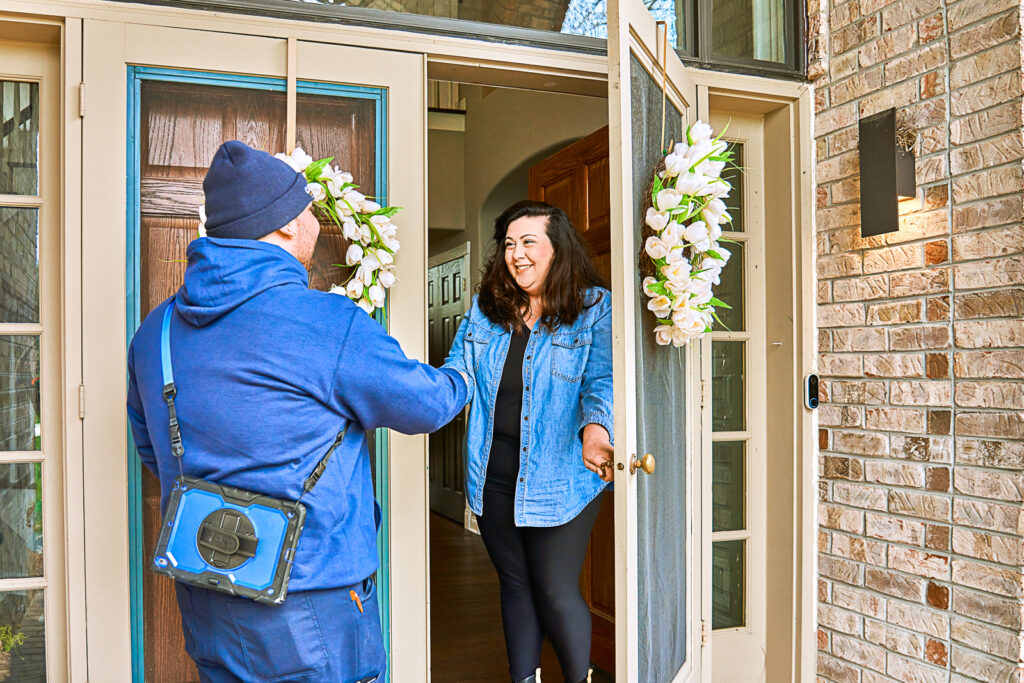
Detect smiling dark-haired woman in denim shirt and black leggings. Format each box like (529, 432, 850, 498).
(445, 202, 612, 683)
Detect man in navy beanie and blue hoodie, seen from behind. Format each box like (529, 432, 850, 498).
(128, 141, 467, 683)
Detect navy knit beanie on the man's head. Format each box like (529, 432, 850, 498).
(203, 140, 312, 240)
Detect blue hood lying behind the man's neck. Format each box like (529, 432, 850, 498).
(175, 238, 309, 328)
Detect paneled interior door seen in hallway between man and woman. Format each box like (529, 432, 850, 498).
(427, 252, 469, 524)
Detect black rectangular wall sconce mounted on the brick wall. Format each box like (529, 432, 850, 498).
(858, 109, 918, 238)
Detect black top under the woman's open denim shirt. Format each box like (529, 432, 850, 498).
(483, 332, 529, 494)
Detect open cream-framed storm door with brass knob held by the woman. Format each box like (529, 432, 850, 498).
(608, 0, 703, 683)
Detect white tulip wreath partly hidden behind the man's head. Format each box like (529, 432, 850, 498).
(199, 147, 401, 314)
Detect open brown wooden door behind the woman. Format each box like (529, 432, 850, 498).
(529, 127, 618, 672)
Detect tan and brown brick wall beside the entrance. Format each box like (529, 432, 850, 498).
(808, 0, 1024, 683)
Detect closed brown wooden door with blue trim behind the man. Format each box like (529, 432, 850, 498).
(137, 72, 378, 683)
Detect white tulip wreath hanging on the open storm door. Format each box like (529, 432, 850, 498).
(642, 121, 732, 346)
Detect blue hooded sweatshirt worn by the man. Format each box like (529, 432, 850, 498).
(128, 238, 467, 591)
